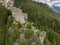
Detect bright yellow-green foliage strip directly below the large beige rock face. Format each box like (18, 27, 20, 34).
(11, 22, 21, 45)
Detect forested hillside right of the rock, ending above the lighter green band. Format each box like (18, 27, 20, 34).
(15, 0, 60, 33)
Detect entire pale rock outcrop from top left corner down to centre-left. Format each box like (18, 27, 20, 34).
(0, 0, 27, 24)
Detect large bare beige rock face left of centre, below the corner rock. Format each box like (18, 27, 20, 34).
(10, 7, 27, 24)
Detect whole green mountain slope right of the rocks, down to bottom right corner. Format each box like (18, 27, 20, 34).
(15, 0, 60, 45)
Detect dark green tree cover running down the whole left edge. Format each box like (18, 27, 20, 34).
(0, 5, 11, 45)
